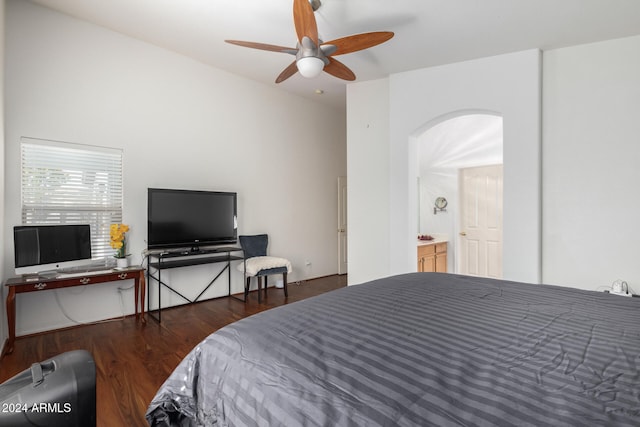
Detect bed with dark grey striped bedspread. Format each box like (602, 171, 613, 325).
(146, 273, 640, 426)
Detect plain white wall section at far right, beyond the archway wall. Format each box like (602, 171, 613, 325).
(542, 36, 640, 292)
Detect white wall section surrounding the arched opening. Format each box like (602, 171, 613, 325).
(347, 50, 541, 283)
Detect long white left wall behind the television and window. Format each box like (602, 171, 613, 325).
(4, 0, 346, 335)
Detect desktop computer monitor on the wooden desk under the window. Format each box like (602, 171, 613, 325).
(13, 224, 91, 274)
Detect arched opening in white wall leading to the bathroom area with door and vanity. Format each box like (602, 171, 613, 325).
(410, 110, 504, 277)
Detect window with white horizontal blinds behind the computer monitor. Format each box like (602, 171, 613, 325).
(21, 138, 123, 259)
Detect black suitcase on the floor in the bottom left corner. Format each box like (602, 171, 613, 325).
(0, 350, 96, 427)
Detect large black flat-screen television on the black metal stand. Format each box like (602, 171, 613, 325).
(147, 188, 238, 251)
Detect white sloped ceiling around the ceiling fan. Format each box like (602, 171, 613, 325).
(27, 0, 640, 108)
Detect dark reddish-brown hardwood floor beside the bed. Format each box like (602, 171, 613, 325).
(0, 276, 347, 427)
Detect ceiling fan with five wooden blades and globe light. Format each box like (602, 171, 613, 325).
(225, 0, 393, 83)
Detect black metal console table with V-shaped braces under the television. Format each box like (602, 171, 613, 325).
(147, 246, 244, 322)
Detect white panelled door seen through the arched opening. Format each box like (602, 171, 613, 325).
(460, 165, 503, 278)
